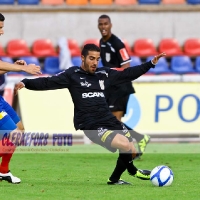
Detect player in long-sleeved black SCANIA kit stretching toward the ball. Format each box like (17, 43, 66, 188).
(15, 44, 165, 185)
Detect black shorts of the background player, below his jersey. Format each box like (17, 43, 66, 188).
(108, 95, 130, 114)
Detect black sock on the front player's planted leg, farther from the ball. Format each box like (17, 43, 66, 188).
(109, 156, 126, 182)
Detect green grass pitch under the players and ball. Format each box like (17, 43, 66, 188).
(0, 144, 200, 200)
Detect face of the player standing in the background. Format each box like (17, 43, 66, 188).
(98, 18, 112, 37)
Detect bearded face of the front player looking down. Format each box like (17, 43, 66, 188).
(81, 51, 100, 74)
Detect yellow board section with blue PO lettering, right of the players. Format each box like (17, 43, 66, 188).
(123, 83, 200, 134)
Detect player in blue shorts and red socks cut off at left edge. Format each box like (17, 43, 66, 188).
(0, 13, 41, 183)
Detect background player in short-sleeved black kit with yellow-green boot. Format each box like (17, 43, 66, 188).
(98, 15, 150, 157)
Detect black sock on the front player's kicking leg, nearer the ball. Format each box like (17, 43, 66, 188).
(119, 150, 137, 175)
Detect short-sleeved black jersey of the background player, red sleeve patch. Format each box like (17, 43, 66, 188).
(100, 34, 135, 104)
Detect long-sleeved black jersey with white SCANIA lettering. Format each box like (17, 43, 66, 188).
(22, 62, 154, 130)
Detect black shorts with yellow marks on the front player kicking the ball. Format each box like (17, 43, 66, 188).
(83, 118, 133, 153)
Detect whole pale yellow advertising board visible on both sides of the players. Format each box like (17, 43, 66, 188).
(19, 83, 200, 134)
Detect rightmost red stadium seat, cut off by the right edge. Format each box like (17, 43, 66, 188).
(183, 38, 200, 56)
